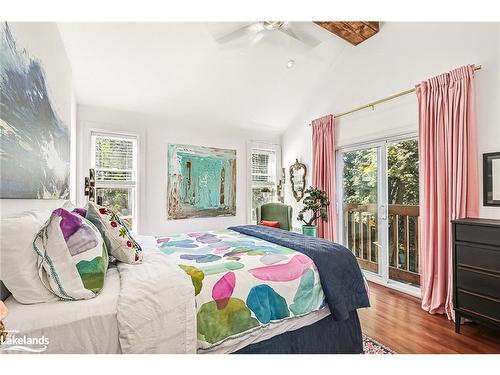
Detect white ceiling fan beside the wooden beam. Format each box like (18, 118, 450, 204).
(215, 21, 321, 48)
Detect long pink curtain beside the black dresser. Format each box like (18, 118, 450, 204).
(416, 66, 479, 319)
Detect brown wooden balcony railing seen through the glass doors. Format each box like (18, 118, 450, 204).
(344, 203, 420, 285)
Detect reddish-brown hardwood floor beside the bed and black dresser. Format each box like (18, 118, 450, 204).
(358, 282, 500, 354)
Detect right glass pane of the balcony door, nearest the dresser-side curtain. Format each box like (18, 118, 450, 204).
(387, 140, 420, 286)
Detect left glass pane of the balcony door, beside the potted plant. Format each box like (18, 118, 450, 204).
(343, 148, 379, 273)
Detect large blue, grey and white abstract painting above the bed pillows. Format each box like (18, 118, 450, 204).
(0, 23, 70, 199)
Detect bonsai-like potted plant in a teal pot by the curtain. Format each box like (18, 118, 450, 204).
(297, 187, 330, 237)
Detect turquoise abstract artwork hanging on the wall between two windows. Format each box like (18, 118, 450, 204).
(167, 144, 236, 220)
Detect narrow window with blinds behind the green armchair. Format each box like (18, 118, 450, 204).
(251, 144, 278, 222)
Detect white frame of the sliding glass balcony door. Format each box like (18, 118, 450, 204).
(335, 132, 421, 298)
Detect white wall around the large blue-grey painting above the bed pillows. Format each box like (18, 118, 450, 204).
(0, 22, 76, 216)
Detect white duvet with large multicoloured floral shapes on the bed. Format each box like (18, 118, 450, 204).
(157, 230, 325, 349)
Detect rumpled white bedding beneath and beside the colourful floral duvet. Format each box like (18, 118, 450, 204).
(5, 236, 330, 353)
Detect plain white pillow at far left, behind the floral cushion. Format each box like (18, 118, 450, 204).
(0, 211, 57, 304)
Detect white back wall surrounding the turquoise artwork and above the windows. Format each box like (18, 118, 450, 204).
(77, 106, 279, 234)
